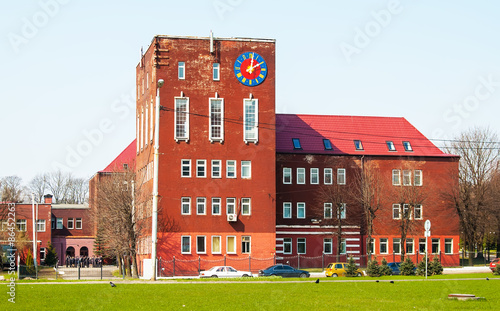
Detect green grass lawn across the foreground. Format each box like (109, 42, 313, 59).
(7, 278, 500, 311)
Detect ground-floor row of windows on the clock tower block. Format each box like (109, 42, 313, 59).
(181, 235, 252, 254)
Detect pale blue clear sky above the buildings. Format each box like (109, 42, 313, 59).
(0, 0, 500, 183)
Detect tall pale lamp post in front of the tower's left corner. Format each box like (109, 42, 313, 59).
(151, 79, 165, 281)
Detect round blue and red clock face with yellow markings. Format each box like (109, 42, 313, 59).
(234, 52, 267, 86)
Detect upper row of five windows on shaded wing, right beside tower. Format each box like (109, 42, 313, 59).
(283, 167, 346, 185)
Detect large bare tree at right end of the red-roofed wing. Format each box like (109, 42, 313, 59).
(446, 128, 499, 264)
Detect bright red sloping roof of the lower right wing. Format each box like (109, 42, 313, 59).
(276, 114, 452, 157)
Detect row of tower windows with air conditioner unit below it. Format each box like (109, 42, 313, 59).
(181, 197, 252, 216)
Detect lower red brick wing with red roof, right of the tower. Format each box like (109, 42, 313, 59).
(276, 114, 459, 267)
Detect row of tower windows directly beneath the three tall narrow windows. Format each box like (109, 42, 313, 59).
(181, 159, 252, 179)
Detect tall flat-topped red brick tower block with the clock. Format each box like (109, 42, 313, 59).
(136, 36, 275, 273)
